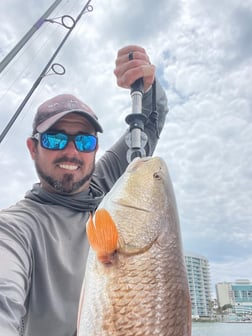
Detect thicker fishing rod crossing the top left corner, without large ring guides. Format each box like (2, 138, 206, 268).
(0, 0, 62, 73)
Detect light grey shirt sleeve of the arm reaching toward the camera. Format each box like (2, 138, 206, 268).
(0, 212, 31, 336)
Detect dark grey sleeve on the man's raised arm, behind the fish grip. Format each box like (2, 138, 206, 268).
(92, 80, 168, 193)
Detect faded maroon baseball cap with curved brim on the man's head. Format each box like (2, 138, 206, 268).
(33, 94, 103, 133)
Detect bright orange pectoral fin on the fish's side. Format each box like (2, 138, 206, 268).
(87, 209, 118, 263)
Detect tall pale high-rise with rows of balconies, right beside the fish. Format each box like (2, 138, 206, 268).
(185, 252, 211, 317)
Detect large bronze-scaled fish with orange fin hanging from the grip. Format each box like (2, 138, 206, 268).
(77, 156, 191, 336)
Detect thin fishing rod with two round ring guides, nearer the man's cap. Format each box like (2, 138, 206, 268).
(0, 0, 93, 143)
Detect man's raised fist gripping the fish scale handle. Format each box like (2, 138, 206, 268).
(114, 45, 155, 91)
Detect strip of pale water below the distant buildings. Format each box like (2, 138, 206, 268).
(192, 322, 252, 336)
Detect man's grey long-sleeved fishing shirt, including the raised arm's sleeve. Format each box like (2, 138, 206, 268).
(0, 82, 168, 336)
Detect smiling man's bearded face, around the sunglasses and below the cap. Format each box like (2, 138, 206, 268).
(27, 113, 97, 194)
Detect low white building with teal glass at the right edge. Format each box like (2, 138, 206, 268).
(215, 279, 252, 314)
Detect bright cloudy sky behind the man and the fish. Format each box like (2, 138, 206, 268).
(0, 0, 252, 296)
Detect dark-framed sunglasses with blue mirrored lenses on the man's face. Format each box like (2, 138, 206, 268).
(32, 132, 98, 152)
